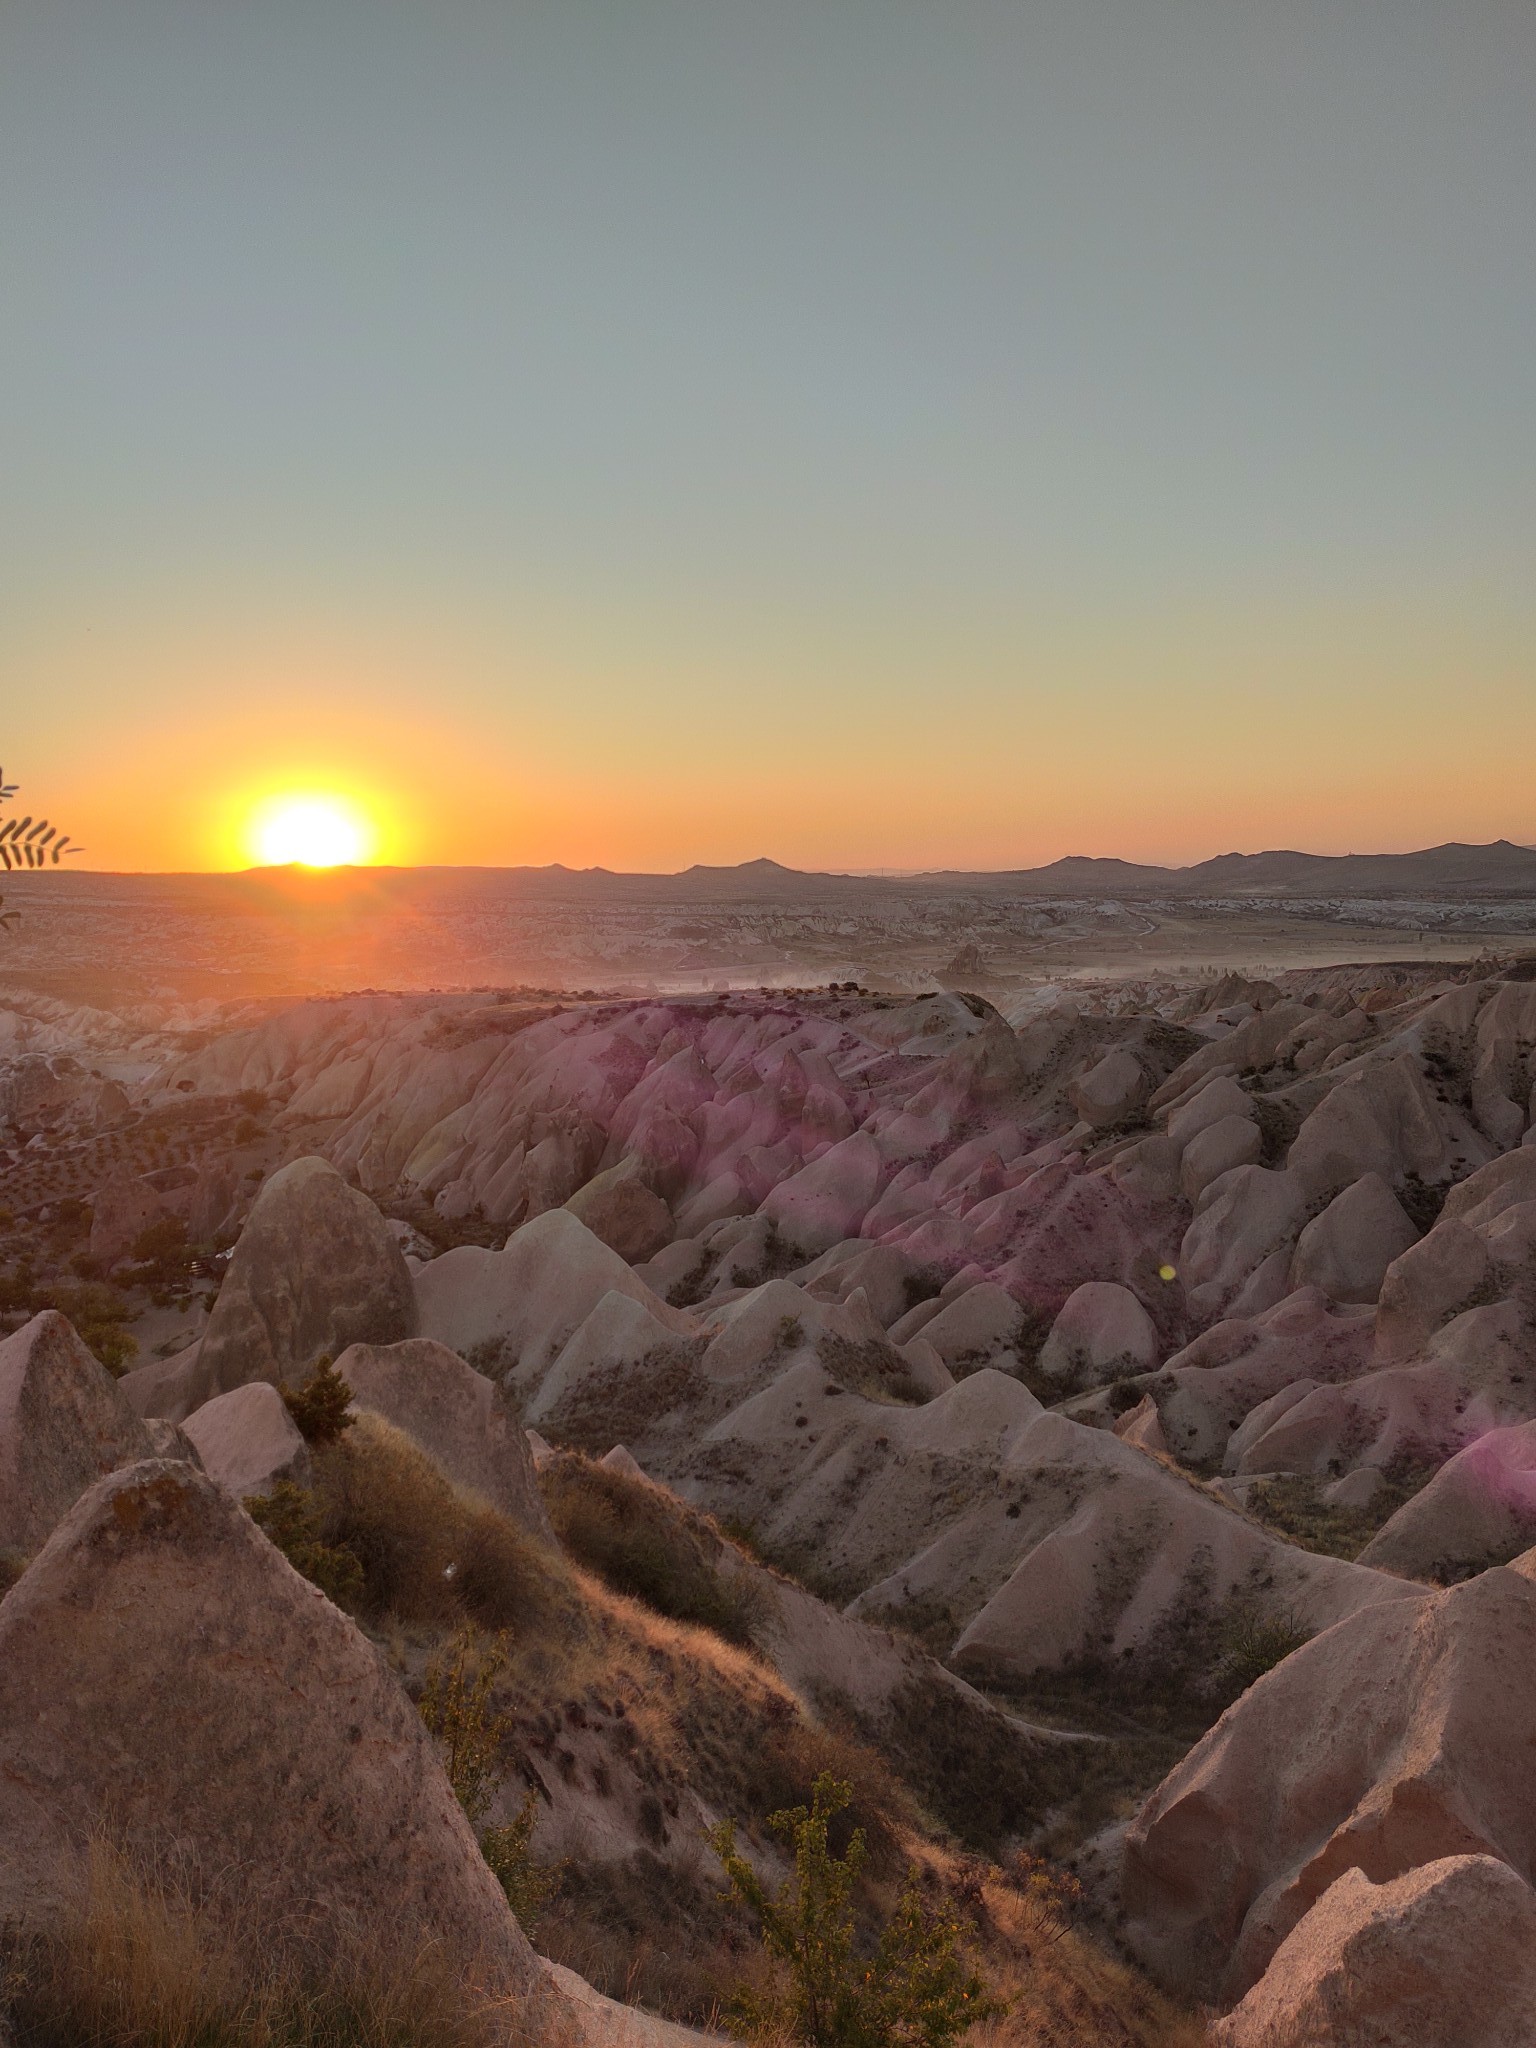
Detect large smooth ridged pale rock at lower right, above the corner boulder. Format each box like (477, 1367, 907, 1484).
(1122, 1569, 1536, 1999)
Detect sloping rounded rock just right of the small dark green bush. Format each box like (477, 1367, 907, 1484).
(335, 1337, 553, 1540)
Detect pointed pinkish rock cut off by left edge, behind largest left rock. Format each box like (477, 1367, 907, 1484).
(0, 1309, 152, 1552)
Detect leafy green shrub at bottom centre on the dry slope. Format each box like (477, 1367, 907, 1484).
(711, 1774, 999, 2048)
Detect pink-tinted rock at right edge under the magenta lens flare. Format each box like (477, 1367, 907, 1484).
(1360, 1421, 1536, 1585)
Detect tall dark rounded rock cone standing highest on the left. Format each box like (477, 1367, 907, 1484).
(192, 1159, 416, 1421)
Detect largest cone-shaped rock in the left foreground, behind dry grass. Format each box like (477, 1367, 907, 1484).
(0, 1460, 547, 2007)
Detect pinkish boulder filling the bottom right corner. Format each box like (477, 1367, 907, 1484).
(1210, 1855, 1536, 2048)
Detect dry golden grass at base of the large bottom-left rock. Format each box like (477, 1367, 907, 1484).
(0, 1841, 504, 2048)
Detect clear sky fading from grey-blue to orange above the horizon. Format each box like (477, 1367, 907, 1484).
(0, 0, 1536, 868)
